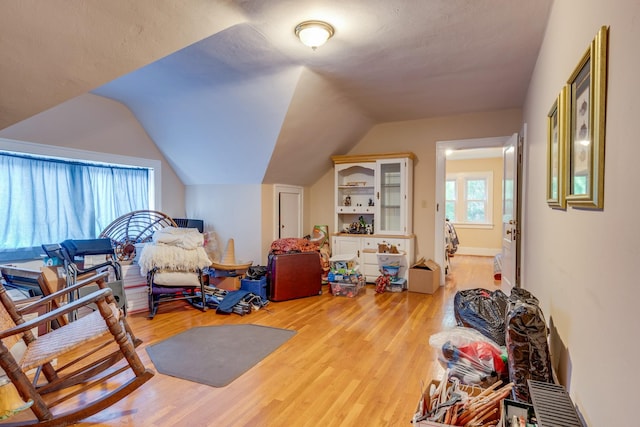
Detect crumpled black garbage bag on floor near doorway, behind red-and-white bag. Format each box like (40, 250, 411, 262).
(453, 288, 508, 346)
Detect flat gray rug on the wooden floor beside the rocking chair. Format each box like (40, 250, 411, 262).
(147, 325, 296, 387)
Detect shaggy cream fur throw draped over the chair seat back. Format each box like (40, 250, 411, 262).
(138, 243, 211, 276)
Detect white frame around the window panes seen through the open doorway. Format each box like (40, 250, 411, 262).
(445, 171, 494, 229)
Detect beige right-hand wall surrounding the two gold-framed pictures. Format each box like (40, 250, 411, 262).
(522, 0, 640, 426)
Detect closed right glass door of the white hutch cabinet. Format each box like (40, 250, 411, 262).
(375, 159, 406, 234)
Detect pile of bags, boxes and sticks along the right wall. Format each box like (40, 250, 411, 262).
(412, 288, 581, 427)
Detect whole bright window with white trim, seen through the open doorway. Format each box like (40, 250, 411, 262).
(445, 171, 493, 226)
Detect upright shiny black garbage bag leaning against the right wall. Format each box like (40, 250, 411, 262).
(505, 288, 553, 403)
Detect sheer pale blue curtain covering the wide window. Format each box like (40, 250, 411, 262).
(0, 153, 149, 260)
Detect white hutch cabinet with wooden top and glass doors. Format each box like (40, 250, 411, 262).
(331, 153, 415, 282)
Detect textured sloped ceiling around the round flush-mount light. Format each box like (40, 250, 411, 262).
(0, 0, 552, 185)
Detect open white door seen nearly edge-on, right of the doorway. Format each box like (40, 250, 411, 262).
(502, 133, 520, 287)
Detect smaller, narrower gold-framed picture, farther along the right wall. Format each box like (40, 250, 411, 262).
(547, 86, 569, 209)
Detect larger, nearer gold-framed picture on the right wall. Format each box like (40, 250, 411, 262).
(566, 27, 609, 209)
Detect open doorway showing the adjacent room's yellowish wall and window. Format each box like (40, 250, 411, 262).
(434, 136, 517, 281)
